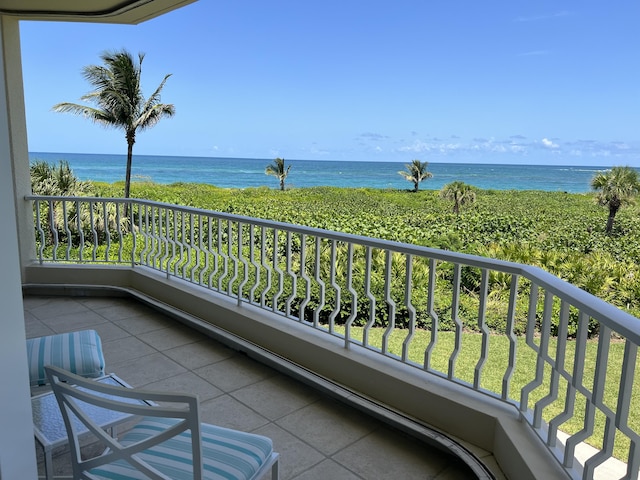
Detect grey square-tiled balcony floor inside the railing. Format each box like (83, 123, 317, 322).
(24, 296, 498, 480)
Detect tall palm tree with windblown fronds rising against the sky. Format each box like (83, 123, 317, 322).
(53, 50, 175, 215)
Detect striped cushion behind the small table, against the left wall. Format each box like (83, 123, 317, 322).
(27, 330, 104, 386)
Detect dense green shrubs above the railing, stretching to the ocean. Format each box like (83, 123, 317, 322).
(94, 179, 640, 316)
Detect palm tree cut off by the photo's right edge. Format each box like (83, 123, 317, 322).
(591, 167, 640, 233)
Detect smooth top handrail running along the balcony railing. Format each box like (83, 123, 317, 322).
(25, 195, 640, 344)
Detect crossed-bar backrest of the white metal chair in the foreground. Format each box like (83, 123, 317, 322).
(45, 366, 202, 480)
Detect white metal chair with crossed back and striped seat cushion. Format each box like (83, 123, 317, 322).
(45, 366, 278, 480)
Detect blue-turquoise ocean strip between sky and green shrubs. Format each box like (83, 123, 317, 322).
(29, 152, 607, 193)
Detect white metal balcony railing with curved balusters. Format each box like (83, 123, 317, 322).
(27, 196, 640, 479)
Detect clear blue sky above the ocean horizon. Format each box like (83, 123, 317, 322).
(21, 0, 640, 166)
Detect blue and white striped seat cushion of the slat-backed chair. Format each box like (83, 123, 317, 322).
(90, 417, 273, 480)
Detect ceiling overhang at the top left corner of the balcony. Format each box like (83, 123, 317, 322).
(0, 0, 196, 24)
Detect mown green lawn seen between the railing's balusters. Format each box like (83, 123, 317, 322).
(336, 327, 640, 462)
